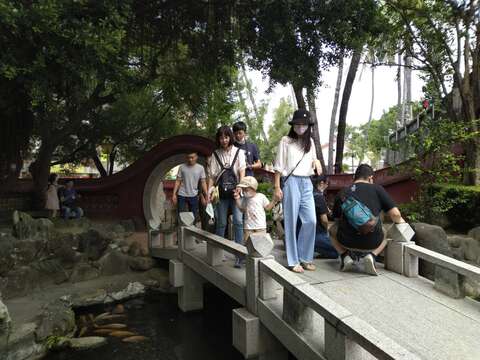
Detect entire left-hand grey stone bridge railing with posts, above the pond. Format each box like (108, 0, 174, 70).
(170, 218, 417, 360)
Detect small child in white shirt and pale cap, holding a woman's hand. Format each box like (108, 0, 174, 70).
(234, 176, 277, 264)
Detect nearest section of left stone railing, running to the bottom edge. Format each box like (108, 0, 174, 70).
(259, 259, 418, 360)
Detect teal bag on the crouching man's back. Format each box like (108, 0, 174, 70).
(341, 185, 378, 235)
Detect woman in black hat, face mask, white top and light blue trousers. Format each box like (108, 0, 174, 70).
(275, 109, 322, 273)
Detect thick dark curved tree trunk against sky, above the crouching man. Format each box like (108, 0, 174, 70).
(335, 49, 362, 174)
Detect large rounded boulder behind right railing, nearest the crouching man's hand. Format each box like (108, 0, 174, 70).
(411, 223, 452, 281)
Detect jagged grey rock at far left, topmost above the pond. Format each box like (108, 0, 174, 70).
(13, 211, 54, 240)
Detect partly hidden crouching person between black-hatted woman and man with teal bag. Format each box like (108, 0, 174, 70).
(312, 175, 338, 259)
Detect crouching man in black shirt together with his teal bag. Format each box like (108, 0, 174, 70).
(330, 164, 405, 275)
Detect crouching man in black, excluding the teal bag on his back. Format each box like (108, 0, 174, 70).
(331, 164, 405, 275)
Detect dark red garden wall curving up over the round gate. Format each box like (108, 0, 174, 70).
(1, 135, 417, 222)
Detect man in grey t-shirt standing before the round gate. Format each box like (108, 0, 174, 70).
(172, 152, 208, 218)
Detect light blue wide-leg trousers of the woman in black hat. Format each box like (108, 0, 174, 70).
(283, 176, 317, 266)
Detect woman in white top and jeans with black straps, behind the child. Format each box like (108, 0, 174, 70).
(208, 126, 246, 267)
